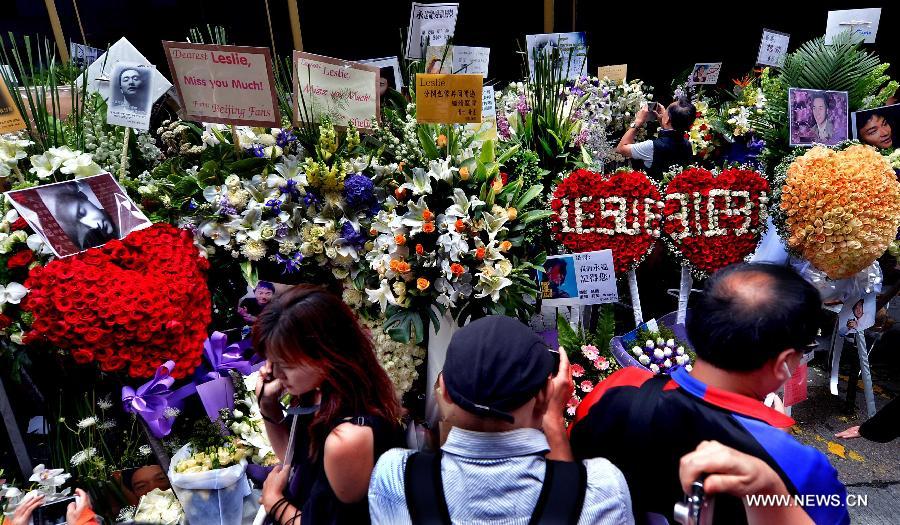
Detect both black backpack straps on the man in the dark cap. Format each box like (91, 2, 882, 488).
(403, 452, 587, 525)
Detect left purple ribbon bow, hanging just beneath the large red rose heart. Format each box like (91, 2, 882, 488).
(122, 361, 196, 438)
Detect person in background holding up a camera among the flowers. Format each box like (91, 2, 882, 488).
(616, 97, 697, 179)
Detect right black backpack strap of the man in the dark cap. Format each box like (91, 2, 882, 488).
(528, 459, 587, 525)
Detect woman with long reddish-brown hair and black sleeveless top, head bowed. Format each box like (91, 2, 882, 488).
(253, 285, 400, 525)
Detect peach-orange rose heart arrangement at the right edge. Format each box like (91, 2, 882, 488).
(781, 145, 900, 279)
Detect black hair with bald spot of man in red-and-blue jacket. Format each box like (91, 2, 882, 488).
(687, 263, 822, 372)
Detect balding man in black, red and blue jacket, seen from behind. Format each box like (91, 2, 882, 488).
(570, 264, 849, 524)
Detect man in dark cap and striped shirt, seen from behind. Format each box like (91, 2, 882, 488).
(369, 316, 634, 525)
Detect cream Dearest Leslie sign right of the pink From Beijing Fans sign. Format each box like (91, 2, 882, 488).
(294, 51, 381, 129)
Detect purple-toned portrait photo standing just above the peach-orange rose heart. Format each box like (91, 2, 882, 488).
(788, 88, 849, 146)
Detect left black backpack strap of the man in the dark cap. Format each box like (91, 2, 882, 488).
(403, 450, 452, 525)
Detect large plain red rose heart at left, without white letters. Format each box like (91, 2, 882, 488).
(24, 224, 211, 378)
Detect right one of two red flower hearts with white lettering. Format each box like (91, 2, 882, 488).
(662, 168, 769, 277)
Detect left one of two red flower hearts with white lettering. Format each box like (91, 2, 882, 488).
(550, 170, 662, 275)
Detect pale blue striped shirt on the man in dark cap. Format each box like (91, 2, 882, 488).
(369, 428, 634, 525)
